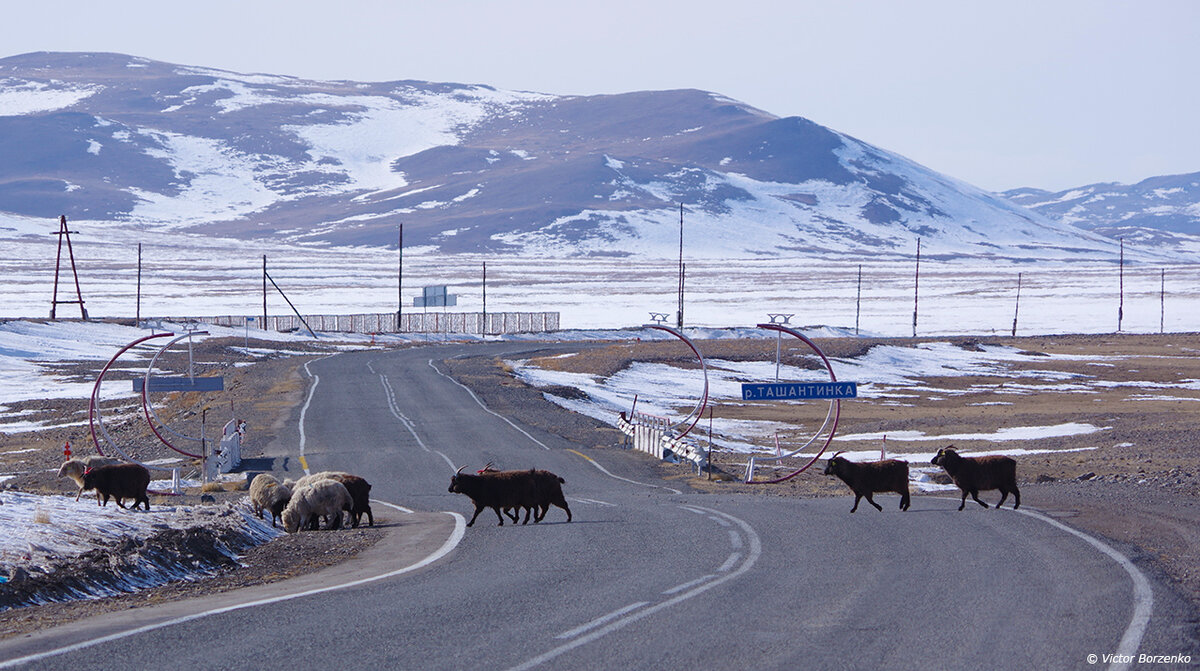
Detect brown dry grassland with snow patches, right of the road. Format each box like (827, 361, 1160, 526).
(533, 334, 1200, 495)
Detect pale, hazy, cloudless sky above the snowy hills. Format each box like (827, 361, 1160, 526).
(0, 0, 1200, 191)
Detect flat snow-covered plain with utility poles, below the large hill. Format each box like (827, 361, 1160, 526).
(0, 220, 1200, 336)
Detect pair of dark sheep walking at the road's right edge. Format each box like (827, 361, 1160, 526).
(824, 445, 1021, 513)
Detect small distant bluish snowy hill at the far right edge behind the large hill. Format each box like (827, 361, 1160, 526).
(1004, 173, 1200, 258)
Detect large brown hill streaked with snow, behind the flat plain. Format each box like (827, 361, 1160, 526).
(0, 53, 1152, 259)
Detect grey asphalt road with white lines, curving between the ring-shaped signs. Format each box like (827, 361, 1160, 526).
(0, 343, 1184, 670)
